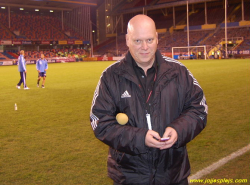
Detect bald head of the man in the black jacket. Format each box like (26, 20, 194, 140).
(126, 15, 158, 67)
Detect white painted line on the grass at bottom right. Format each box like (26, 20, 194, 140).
(188, 144, 250, 179)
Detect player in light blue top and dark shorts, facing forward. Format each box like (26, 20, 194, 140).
(36, 54, 48, 88)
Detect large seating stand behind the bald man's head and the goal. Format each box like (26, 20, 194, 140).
(95, 0, 250, 56)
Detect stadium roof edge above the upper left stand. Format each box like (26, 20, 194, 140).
(0, 0, 99, 10)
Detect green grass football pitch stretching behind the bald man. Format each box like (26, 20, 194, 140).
(0, 59, 250, 185)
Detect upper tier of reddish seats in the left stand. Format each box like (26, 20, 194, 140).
(0, 12, 83, 40)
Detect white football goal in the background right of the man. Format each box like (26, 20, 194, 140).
(172, 45, 211, 60)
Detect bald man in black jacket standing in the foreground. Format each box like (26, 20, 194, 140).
(90, 15, 208, 185)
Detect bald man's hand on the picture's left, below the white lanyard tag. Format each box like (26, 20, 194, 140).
(145, 130, 165, 148)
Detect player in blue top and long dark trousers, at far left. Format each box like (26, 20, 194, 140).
(16, 50, 29, 89)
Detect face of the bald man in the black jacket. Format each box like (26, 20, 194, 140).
(126, 26, 158, 66)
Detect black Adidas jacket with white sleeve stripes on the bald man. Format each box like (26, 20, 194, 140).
(90, 50, 208, 185)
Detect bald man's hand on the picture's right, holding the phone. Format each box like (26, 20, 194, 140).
(160, 127, 178, 150)
